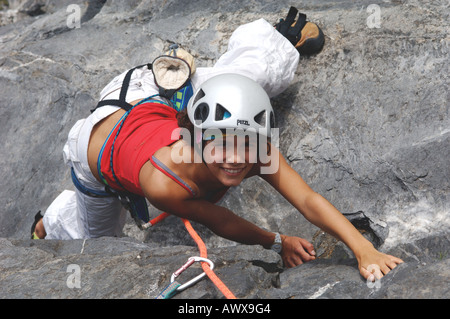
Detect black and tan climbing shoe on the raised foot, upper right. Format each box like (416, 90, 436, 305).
(275, 7, 325, 55)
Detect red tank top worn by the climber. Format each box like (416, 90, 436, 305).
(100, 102, 180, 196)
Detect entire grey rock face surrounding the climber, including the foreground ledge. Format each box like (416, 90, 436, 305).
(0, 0, 450, 298)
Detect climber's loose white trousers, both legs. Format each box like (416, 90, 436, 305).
(43, 19, 299, 239)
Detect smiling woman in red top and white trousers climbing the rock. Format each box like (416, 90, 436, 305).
(32, 9, 402, 280)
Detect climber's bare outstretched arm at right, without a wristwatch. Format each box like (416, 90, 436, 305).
(261, 148, 402, 280)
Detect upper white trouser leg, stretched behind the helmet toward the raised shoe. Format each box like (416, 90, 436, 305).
(100, 19, 300, 102)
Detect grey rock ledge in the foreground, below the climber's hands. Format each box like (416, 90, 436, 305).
(0, 236, 450, 299)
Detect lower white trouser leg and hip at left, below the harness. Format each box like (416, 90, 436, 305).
(43, 107, 126, 239)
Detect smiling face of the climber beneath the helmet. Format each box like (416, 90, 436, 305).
(203, 135, 257, 187)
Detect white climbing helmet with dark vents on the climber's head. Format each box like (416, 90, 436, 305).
(187, 74, 275, 138)
